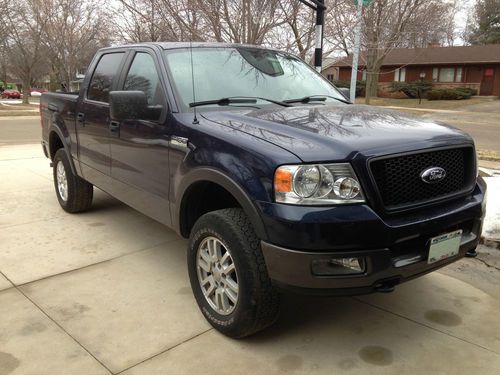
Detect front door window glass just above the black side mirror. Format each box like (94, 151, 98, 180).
(123, 52, 163, 105)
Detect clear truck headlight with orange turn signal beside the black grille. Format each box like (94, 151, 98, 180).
(274, 163, 365, 205)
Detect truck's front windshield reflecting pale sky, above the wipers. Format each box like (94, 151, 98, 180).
(165, 47, 345, 111)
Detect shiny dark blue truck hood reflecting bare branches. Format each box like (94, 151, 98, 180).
(202, 105, 472, 162)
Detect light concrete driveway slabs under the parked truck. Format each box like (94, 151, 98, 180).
(0, 145, 500, 375)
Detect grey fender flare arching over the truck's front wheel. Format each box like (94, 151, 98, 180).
(172, 167, 267, 240)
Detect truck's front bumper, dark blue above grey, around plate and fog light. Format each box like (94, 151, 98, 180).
(261, 180, 486, 295)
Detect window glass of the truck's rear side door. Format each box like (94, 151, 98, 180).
(87, 52, 123, 103)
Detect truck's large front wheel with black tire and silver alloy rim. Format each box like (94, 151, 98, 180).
(188, 208, 280, 338)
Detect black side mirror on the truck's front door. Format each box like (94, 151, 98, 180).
(109, 91, 163, 121)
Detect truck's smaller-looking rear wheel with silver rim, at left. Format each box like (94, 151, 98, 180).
(53, 148, 94, 213)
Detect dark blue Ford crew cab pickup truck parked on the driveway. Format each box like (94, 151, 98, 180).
(40, 43, 486, 337)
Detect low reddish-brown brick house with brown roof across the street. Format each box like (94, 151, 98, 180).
(328, 44, 500, 96)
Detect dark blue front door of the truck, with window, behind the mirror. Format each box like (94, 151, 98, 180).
(110, 50, 171, 226)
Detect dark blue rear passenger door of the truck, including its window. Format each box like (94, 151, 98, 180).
(76, 51, 126, 190)
